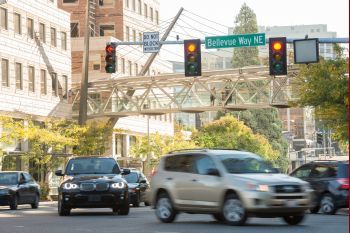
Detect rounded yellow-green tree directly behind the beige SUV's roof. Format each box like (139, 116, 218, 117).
(192, 115, 279, 163)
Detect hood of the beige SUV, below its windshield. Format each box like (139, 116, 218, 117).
(230, 173, 306, 184)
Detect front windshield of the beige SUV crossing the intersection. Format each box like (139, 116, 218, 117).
(219, 153, 276, 173)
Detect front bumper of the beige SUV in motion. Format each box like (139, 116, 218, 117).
(241, 191, 312, 216)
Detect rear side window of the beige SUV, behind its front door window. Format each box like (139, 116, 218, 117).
(164, 155, 194, 173)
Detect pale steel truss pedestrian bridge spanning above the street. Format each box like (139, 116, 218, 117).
(70, 66, 299, 119)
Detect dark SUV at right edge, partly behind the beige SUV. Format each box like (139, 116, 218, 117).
(290, 160, 349, 214)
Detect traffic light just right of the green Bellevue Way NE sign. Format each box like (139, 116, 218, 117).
(269, 37, 287, 75)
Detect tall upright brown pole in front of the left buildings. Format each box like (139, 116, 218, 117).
(78, 0, 90, 125)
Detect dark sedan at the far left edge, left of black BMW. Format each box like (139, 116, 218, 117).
(0, 171, 40, 210)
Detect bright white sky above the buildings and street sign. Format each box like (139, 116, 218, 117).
(159, 0, 349, 60)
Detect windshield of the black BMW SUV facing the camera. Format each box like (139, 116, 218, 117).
(66, 158, 120, 175)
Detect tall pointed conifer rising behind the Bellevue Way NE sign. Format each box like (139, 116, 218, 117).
(232, 3, 260, 68)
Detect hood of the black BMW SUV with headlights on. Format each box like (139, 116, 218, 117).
(64, 174, 125, 183)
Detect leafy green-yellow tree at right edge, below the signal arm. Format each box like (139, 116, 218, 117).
(292, 45, 349, 144)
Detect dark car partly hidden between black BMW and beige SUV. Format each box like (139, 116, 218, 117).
(123, 169, 150, 207)
